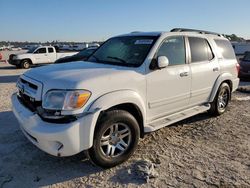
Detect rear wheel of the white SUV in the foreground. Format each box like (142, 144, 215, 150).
(209, 83, 231, 116)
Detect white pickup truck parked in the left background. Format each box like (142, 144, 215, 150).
(9, 46, 77, 69)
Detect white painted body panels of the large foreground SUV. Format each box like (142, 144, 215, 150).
(12, 32, 239, 156)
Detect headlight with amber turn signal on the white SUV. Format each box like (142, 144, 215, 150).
(42, 90, 91, 110)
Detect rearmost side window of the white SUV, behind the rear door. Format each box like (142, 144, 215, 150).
(214, 40, 235, 59)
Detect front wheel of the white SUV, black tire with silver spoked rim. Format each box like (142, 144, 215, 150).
(87, 110, 140, 168)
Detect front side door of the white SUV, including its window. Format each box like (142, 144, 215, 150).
(147, 36, 191, 122)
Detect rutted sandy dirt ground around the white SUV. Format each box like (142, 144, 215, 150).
(0, 63, 250, 187)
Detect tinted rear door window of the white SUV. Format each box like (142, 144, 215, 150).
(188, 37, 214, 63)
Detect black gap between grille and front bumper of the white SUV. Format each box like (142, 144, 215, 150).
(18, 92, 42, 112)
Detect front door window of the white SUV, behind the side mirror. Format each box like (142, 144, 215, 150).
(157, 36, 186, 65)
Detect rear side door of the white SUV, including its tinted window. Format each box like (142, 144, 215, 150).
(188, 37, 220, 106)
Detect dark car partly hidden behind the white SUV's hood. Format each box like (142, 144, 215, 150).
(55, 47, 97, 63)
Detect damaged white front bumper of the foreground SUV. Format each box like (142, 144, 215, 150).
(11, 94, 99, 156)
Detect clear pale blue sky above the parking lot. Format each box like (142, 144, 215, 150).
(0, 0, 250, 42)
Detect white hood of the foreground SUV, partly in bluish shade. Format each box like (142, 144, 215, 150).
(24, 61, 144, 91)
